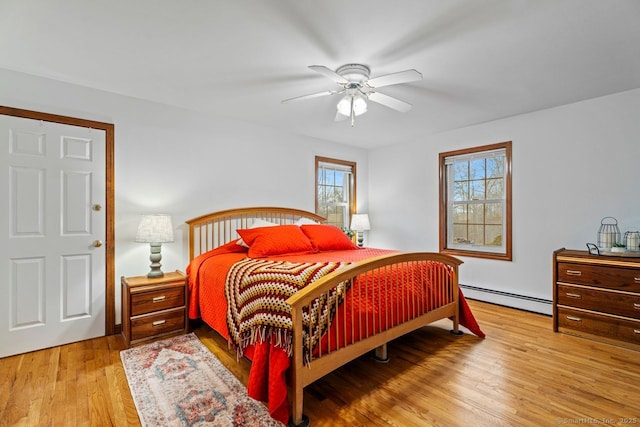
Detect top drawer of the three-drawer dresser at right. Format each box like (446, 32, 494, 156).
(556, 262, 640, 292)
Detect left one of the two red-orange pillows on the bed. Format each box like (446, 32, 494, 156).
(238, 225, 316, 258)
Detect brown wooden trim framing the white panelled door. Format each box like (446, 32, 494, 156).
(0, 105, 116, 335)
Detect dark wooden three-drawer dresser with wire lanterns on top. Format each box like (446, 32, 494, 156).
(553, 249, 640, 350)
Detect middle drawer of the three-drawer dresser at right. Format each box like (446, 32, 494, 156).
(558, 284, 640, 320)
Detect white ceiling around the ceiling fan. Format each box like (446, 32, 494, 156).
(0, 0, 640, 147)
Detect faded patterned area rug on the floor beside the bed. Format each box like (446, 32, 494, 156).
(120, 333, 283, 427)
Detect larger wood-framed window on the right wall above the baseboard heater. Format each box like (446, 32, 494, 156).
(440, 141, 511, 261)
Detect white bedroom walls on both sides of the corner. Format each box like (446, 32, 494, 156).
(0, 69, 640, 319)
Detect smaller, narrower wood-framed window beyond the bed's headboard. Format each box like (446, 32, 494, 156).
(316, 156, 356, 228)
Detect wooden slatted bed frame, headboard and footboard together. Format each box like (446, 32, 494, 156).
(187, 207, 462, 425)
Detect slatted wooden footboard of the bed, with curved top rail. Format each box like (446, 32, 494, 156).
(287, 252, 462, 425)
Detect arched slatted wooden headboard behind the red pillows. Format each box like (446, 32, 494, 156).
(186, 206, 326, 260)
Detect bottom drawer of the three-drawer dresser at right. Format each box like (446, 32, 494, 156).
(558, 307, 640, 344)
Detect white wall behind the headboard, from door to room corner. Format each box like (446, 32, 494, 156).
(0, 69, 368, 323)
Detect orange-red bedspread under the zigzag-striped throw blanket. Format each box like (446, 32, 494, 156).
(187, 241, 484, 424)
